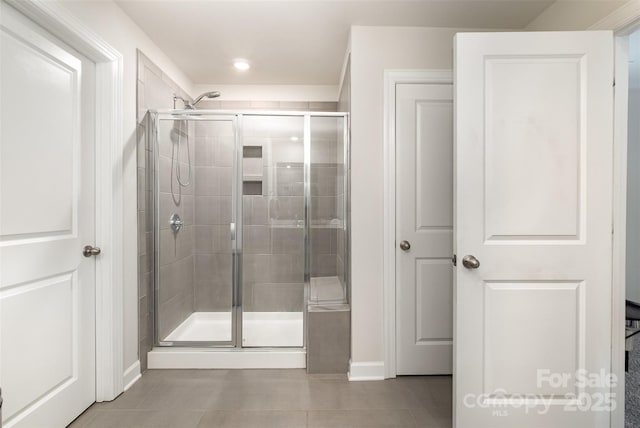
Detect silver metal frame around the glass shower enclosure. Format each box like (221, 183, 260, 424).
(148, 110, 351, 351)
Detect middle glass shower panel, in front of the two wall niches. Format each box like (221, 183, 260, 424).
(242, 115, 306, 347)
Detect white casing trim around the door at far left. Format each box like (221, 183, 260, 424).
(6, 0, 124, 401)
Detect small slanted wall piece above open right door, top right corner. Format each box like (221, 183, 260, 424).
(525, 0, 625, 31)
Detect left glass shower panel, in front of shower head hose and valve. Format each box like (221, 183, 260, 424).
(154, 113, 237, 346)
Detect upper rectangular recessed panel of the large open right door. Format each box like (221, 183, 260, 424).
(484, 55, 587, 241)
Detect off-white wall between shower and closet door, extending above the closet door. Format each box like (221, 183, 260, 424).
(351, 26, 458, 363)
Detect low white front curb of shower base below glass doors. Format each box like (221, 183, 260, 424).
(147, 348, 307, 369)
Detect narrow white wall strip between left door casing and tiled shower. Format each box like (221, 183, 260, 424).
(61, 0, 193, 380)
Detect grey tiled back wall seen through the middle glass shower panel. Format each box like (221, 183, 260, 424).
(242, 117, 304, 312)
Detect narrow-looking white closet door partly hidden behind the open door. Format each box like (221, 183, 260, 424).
(396, 83, 453, 375)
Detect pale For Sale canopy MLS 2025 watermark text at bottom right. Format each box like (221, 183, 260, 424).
(463, 369, 618, 417)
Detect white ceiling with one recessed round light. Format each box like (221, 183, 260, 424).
(116, 0, 553, 85)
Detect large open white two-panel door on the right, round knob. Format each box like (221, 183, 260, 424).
(454, 32, 624, 428)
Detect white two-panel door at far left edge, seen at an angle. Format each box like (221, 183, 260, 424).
(0, 2, 96, 428)
